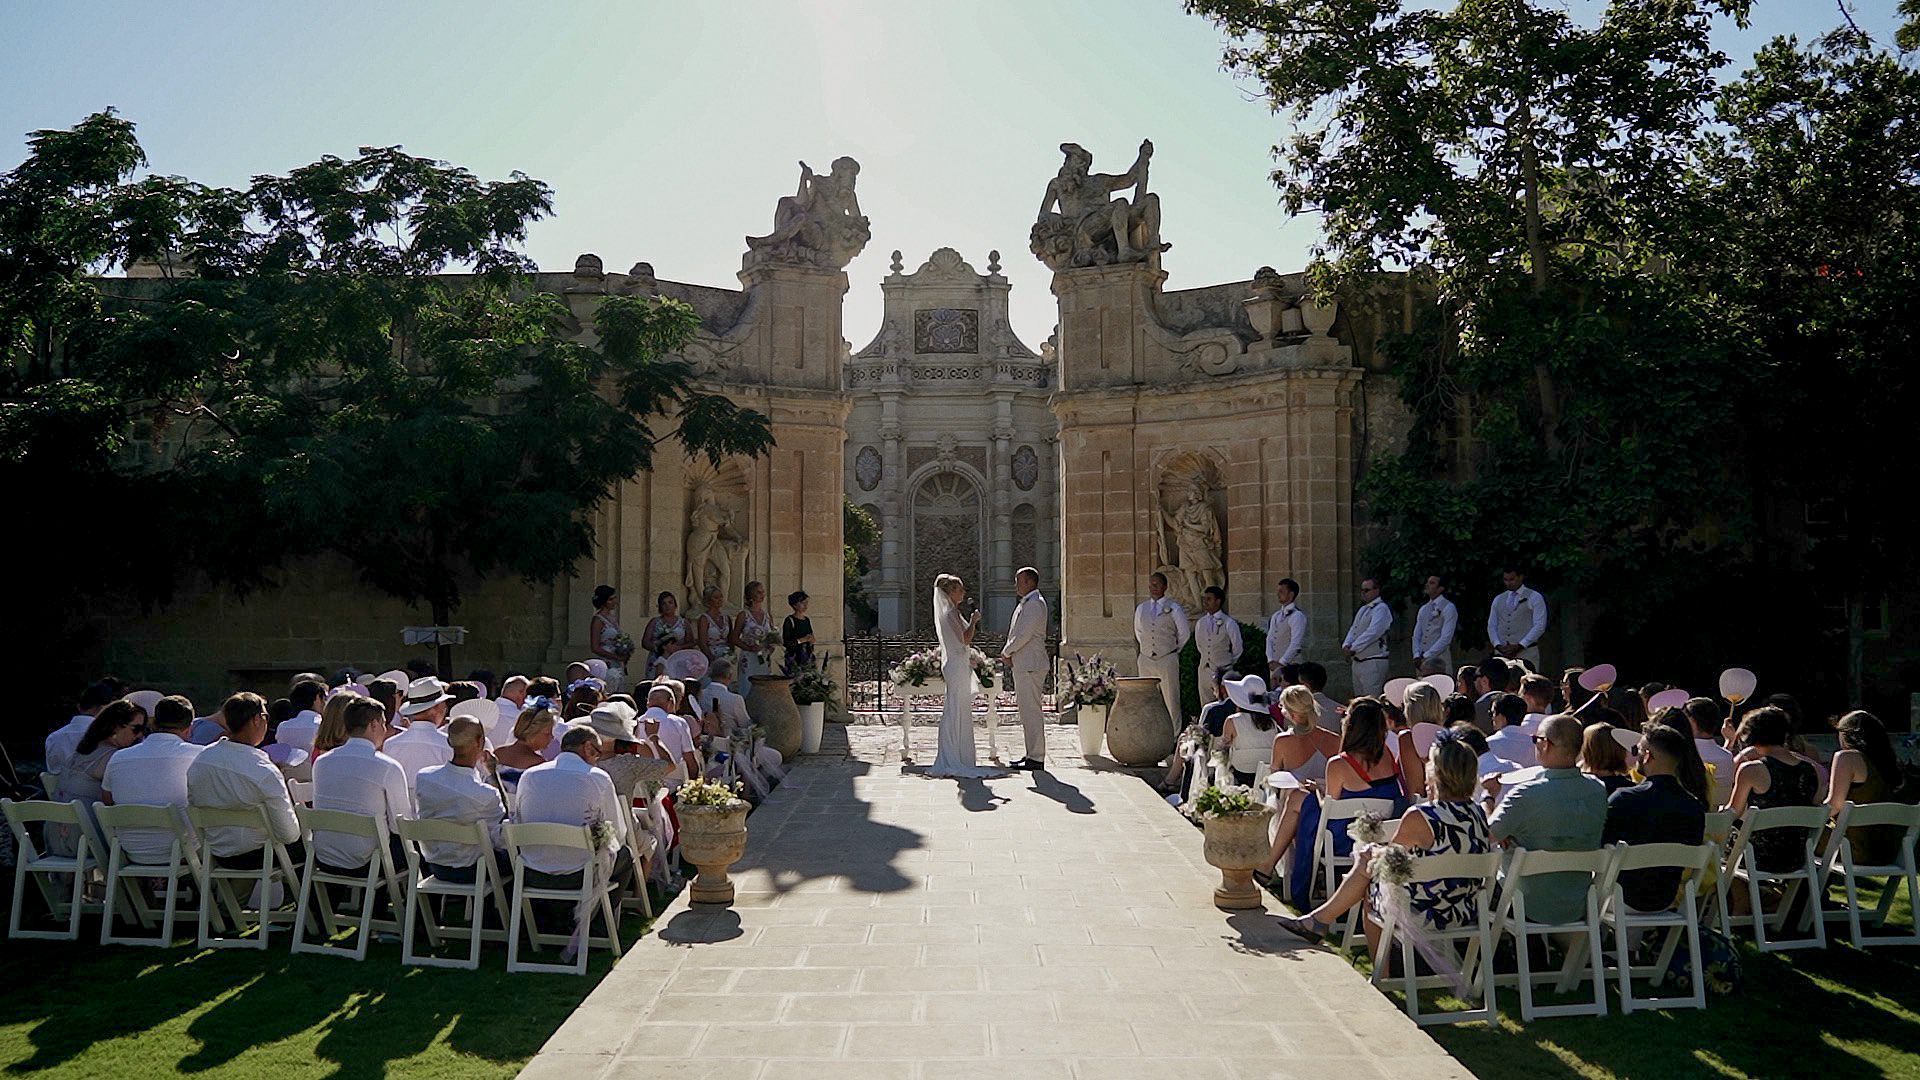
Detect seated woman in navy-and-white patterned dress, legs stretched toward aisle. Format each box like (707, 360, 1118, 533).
(1279, 724, 1492, 951)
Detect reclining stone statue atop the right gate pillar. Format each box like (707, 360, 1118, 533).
(1029, 140, 1173, 271)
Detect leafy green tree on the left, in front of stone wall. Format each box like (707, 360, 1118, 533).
(0, 113, 772, 669)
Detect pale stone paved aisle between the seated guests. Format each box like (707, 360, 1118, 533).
(522, 724, 1471, 1080)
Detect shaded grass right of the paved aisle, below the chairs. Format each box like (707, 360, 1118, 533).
(1367, 890, 1920, 1080)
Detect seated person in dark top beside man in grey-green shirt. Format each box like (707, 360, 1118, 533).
(1599, 724, 1707, 911)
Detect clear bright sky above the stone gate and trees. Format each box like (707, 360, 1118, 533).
(0, 0, 1895, 348)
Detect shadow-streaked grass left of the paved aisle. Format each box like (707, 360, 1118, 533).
(0, 897, 660, 1080)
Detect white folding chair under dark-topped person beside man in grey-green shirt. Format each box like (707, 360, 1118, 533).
(1599, 844, 1713, 1013)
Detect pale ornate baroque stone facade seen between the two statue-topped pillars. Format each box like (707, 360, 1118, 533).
(847, 248, 1058, 632)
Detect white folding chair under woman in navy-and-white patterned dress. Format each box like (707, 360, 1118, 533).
(1373, 851, 1500, 1028)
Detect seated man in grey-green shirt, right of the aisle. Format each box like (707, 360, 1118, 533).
(1486, 715, 1607, 922)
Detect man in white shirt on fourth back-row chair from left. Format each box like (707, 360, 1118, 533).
(313, 698, 413, 871)
